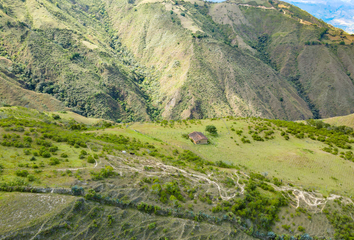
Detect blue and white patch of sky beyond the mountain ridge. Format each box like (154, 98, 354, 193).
(283, 0, 354, 34)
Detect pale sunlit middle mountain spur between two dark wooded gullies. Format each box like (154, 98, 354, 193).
(107, 2, 311, 119)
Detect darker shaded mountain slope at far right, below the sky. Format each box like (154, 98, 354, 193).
(210, 0, 353, 117)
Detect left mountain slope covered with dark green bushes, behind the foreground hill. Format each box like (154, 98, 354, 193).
(1, 0, 156, 120)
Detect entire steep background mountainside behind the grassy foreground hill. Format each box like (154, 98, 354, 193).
(0, 0, 354, 122)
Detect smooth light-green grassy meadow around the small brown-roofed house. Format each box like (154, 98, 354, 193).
(104, 119, 354, 196)
